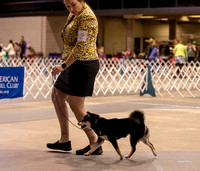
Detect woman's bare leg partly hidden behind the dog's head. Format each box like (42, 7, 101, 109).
(69, 96, 97, 146)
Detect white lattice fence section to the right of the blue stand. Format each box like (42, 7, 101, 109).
(152, 62, 200, 97)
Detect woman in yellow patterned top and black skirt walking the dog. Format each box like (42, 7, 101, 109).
(47, 0, 103, 155)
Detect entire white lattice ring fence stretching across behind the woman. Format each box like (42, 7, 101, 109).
(0, 57, 200, 101)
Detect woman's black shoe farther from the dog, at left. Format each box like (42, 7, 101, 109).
(47, 141, 72, 151)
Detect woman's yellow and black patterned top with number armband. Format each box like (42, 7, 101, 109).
(61, 3, 98, 61)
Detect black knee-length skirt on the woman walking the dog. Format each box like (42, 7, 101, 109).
(54, 60, 99, 97)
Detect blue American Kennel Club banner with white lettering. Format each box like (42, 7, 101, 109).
(0, 67, 24, 99)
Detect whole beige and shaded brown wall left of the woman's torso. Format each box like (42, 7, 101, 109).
(0, 16, 66, 56)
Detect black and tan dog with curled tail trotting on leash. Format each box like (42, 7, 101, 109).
(78, 110, 157, 159)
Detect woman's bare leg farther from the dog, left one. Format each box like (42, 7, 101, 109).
(52, 87, 69, 143)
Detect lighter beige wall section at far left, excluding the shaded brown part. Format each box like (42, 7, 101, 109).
(0, 17, 42, 52)
